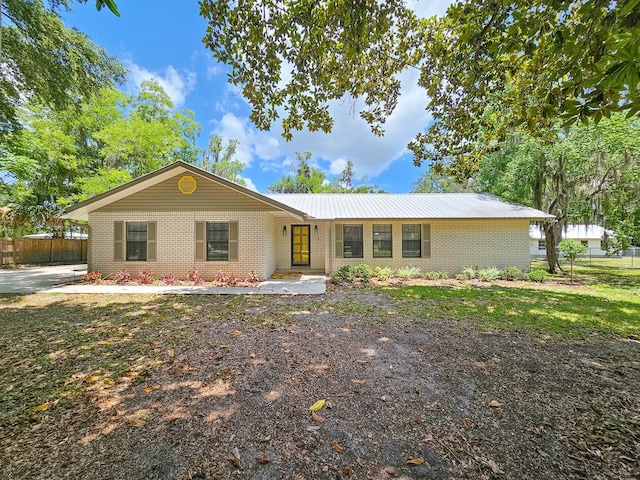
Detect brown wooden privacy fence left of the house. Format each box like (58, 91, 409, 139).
(0, 238, 87, 265)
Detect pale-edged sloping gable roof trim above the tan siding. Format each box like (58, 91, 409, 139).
(62, 161, 306, 220)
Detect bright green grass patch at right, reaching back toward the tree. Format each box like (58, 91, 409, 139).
(388, 265, 640, 338)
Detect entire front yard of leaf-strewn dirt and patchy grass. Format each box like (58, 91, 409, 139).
(0, 272, 640, 479)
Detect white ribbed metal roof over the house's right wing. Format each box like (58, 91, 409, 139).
(266, 193, 552, 220)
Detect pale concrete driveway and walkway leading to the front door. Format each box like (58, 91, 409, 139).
(0, 265, 326, 295)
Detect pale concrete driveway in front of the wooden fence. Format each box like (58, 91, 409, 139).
(0, 264, 87, 293)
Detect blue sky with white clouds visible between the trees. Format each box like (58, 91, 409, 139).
(64, 0, 449, 193)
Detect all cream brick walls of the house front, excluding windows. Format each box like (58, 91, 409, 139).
(89, 212, 530, 279)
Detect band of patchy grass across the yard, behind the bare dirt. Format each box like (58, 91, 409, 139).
(0, 265, 640, 434)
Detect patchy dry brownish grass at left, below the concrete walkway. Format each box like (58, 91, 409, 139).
(0, 295, 254, 442)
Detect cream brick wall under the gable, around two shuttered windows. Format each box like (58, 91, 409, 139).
(89, 212, 275, 280)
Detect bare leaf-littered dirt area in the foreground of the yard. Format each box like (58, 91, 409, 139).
(0, 288, 640, 480)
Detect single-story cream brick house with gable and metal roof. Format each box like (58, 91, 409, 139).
(64, 162, 550, 279)
